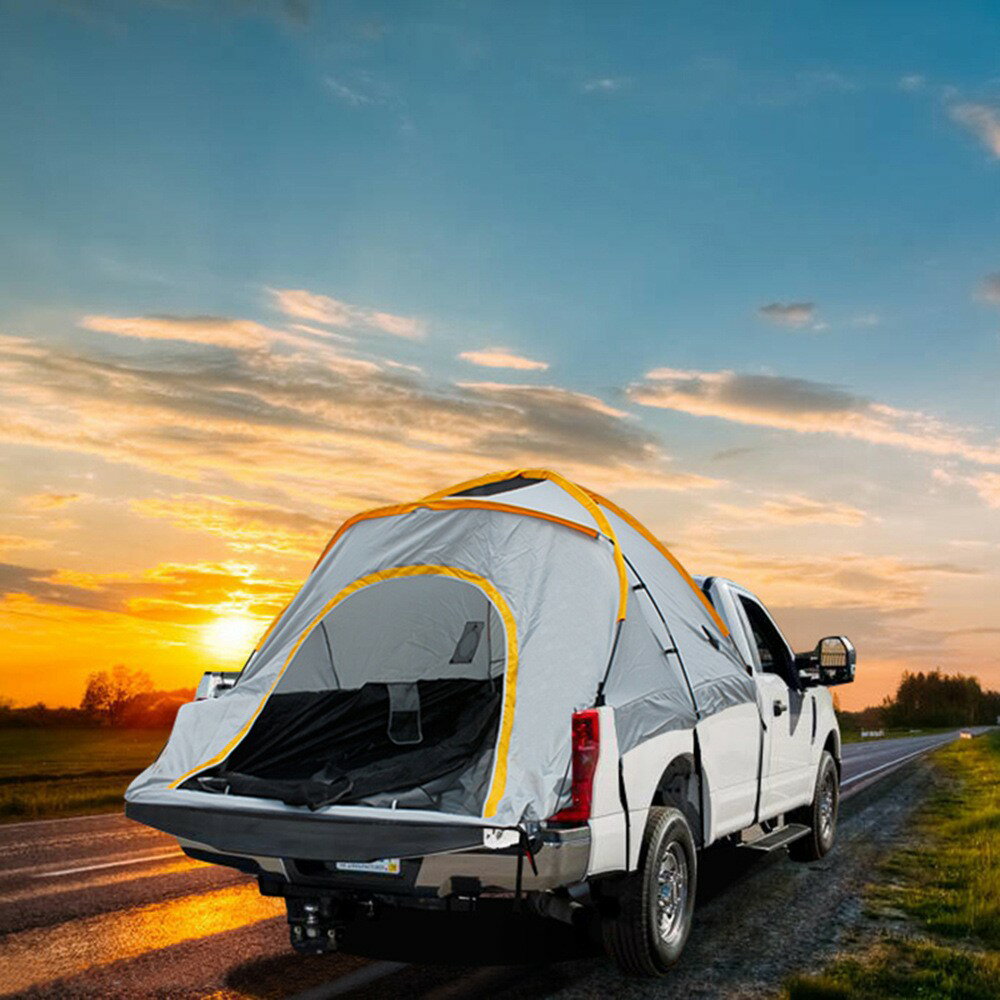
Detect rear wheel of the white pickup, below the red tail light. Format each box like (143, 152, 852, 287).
(601, 806, 698, 976)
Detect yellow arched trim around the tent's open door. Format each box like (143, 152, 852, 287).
(170, 566, 517, 818)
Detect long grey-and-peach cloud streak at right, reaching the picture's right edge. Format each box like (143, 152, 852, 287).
(628, 368, 1000, 465)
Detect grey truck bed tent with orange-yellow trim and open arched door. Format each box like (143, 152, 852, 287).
(127, 469, 755, 827)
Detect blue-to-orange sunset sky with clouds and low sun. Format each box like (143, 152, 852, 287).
(0, 0, 1000, 708)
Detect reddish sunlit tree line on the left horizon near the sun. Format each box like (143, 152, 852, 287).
(0, 664, 194, 729)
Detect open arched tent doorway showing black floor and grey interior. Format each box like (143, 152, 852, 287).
(185, 574, 507, 815)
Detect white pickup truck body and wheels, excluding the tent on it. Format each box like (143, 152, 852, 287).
(181, 577, 856, 976)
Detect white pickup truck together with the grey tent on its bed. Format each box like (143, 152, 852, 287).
(126, 470, 855, 976)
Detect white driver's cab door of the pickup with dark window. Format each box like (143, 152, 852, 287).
(734, 588, 816, 819)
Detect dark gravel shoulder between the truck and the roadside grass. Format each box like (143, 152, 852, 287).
(332, 760, 932, 1000)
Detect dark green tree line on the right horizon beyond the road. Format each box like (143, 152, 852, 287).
(838, 670, 1000, 729)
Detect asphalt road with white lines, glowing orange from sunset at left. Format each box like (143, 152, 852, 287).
(0, 731, 984, 1000)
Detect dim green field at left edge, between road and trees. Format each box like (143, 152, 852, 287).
(0, 727, 168, 823)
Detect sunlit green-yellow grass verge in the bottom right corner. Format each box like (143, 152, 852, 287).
(785, 730, 1000, 1000)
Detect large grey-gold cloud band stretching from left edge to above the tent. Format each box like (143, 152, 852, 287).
(0, 318, 714, 508)
